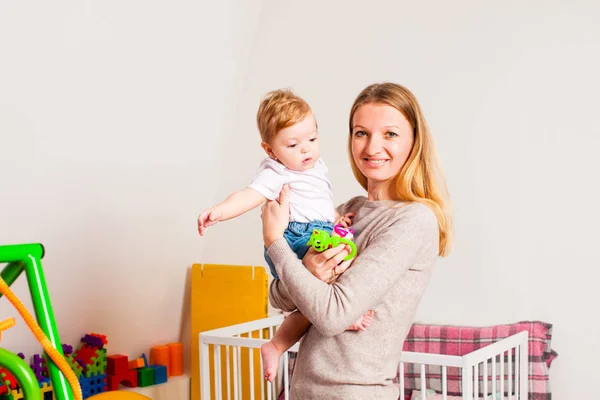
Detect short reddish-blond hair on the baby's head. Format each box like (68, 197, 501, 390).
(256, 89, 312, 143)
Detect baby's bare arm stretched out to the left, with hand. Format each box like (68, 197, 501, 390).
(198, 187, 266, 236)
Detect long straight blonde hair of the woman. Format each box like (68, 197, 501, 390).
(348, 82, 452, 256)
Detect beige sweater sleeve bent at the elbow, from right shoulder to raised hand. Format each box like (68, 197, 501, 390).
(268, 205, 439, 336)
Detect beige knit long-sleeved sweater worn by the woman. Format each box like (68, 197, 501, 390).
(268, 197, 439, 400)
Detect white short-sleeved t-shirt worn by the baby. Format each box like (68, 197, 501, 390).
(248, 157, 335, 222)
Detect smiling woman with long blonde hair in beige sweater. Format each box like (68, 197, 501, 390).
(262, 83, 451, 399)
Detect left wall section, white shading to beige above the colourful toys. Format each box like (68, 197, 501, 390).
(0, 0, 262, 374)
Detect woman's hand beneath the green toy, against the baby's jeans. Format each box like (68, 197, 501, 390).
(302, 244, 354, 283)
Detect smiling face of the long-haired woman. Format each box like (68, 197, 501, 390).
(351, 103, 414, 194)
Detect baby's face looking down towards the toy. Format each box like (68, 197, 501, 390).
(270, 113, 321, 171)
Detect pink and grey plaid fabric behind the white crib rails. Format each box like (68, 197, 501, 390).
(402, 321, 557, 400)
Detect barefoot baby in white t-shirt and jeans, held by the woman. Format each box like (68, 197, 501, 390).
(198, 90, 372, 382)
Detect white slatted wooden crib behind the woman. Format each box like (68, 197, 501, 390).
(199, 316, 528, 400)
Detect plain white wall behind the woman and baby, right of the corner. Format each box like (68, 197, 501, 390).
(203, 0, 600, 399)
